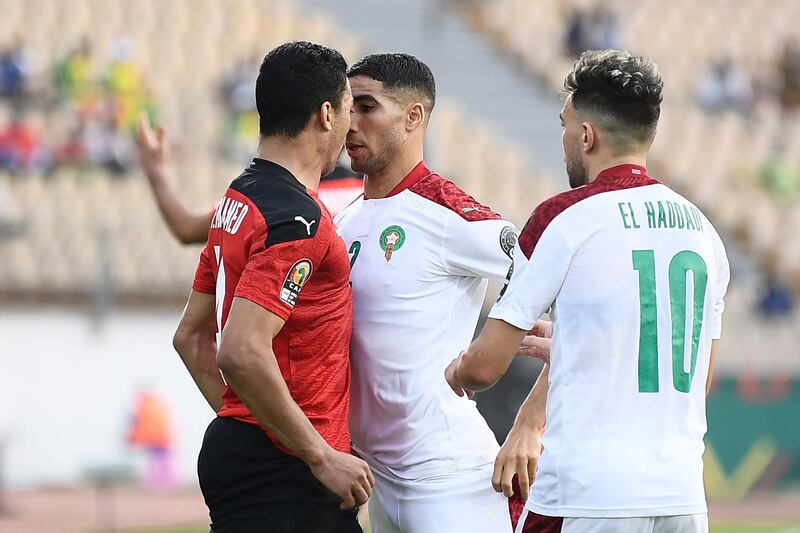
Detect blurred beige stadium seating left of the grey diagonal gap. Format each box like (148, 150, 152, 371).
(0, 0, 552, 301)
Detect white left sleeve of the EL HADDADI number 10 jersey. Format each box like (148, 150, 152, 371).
(489, 215, 573, 330)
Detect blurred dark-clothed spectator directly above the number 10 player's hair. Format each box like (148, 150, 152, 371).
(564, 5, 621, 58)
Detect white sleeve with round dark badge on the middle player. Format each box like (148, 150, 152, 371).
(443, 217, 518, 281)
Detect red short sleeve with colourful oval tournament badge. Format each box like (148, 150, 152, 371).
(234, 225, 328, 320)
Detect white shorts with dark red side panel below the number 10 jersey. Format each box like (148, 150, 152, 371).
(515, 509, 708, 533)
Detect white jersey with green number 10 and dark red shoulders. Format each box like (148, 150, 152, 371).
(489, 165, 730, 518)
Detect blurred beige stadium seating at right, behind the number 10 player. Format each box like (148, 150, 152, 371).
(469, 0, 800, 375)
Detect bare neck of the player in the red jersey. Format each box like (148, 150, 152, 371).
(256, 133, 322, 191)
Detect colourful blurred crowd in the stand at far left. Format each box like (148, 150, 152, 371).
(0, 38, 155, 176)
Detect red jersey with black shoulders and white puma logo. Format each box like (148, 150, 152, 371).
(192, 159, 353, 452)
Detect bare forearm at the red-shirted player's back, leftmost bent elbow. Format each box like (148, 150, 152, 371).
(175, 332, 225, 413)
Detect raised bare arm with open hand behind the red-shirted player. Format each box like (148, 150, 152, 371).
(136, 113, 212, 244)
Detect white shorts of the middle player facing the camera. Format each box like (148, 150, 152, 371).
(369, 464, 512, 533)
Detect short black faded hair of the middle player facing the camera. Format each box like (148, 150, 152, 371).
(347, 54, 436, 114)
